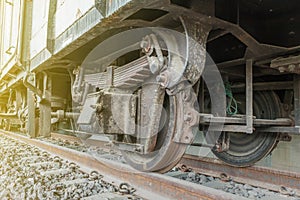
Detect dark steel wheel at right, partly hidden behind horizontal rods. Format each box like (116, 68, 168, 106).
(213, 91, 281, 167)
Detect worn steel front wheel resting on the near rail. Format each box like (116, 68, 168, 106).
(122, 95, 187, 173)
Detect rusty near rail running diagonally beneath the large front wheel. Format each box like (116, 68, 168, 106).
(1, 132, 243, 200)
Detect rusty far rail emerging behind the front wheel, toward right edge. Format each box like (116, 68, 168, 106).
(180, 155, 300, 195)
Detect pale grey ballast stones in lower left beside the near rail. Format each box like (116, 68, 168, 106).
(0, 135, 138, 200)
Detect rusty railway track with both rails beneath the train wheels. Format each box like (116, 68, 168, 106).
(0, 132, 300, 200)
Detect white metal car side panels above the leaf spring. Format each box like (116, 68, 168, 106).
(30, 0, 135, 71)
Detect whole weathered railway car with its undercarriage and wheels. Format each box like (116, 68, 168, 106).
(0, 0, 300, 172)
